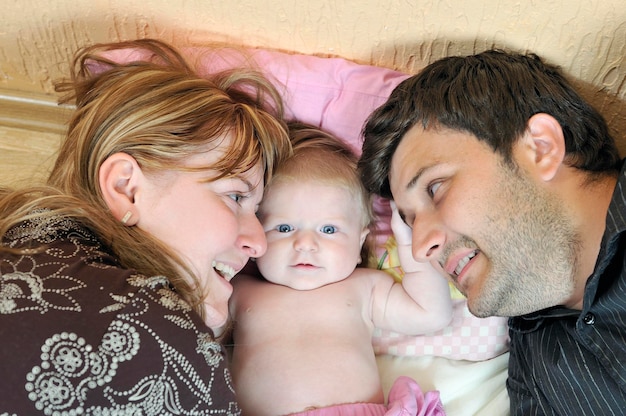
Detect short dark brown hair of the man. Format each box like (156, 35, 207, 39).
(359, 50, 620, 198)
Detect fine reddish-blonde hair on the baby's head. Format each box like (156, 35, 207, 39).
(260, 122, 375, 266)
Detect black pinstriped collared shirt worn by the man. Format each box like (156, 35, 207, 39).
(507, 164, 626, 416)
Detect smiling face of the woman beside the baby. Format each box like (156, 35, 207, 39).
(135, 136, 267, 328)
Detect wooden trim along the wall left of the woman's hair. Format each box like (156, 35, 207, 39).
(0, 89, 73, 134)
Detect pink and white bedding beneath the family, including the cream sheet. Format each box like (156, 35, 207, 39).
(0, 47, 509, 416)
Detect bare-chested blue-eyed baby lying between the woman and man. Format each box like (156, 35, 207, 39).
(230, 124, 452, 416)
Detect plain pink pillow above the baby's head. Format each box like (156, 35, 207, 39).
(188, 48, 400, 245)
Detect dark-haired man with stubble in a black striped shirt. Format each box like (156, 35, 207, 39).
(359, 50, 626, 416)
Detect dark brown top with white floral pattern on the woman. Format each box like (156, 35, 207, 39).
(0, 214, 240, 415)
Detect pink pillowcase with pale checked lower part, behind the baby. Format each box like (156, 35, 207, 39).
(110, 47, 508, 361)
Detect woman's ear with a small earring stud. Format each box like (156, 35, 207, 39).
(98, 153, 142, 226)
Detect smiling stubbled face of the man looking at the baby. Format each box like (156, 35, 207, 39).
(389, 125, 578, 317)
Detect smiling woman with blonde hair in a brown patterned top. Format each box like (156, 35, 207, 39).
(0, 40, 291, 415)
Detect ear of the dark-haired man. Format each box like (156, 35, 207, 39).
(523, 113, 565, 181)
